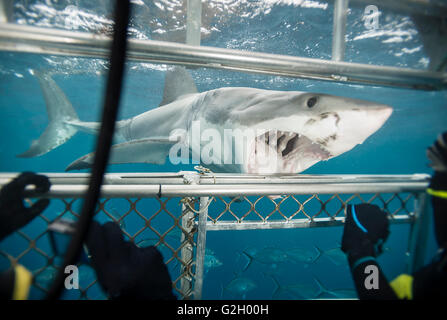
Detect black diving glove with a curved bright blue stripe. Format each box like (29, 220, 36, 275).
(341, 203, 389, 266)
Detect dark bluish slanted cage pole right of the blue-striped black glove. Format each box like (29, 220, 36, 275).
(407, 192, 431, 274)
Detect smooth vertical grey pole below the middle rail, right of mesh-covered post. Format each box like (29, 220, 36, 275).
(194, 197, 210, 300)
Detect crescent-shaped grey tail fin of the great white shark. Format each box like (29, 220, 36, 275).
(17, 71, 79, 158)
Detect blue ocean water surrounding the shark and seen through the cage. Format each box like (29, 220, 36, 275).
(0, 1, 447, 299)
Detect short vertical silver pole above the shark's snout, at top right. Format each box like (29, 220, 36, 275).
(332, 0, 349, 61)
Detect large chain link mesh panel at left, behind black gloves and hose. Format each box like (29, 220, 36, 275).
(0, 198, 200, 299)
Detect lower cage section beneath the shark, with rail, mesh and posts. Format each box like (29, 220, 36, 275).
(0, 171, 429, 299)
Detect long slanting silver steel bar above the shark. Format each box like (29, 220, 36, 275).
(0, 23, 447, 90)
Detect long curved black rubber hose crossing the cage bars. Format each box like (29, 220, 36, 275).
(46, 0, 130, 300)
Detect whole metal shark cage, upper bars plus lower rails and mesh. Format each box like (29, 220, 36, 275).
(0, 0, 447, 299)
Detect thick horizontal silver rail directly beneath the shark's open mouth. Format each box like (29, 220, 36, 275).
(0, 173, 428, 198)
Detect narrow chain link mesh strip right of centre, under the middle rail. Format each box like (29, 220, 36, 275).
(208, 193, 416, 228)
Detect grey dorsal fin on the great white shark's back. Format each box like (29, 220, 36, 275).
(160, 67, 198, 106)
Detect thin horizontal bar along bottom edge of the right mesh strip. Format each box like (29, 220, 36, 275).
(206, 215, 413, 231)
